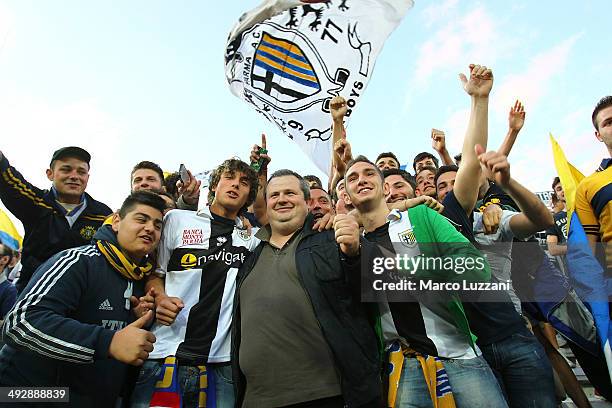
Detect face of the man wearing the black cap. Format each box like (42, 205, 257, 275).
(47, 157, 89, 204)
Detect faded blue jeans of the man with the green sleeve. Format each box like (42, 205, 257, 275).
(395, 356, 508, 408)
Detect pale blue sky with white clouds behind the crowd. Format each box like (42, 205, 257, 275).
(0, 0, 612, 233)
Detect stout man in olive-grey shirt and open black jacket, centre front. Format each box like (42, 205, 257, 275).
(232, 170, 381, 407)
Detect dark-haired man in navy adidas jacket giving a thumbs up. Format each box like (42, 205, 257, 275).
(0, 191, 165, 407)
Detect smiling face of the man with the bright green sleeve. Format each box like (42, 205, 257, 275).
(345, 162, 387, 212)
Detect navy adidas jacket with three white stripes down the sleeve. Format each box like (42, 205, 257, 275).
(0, 226, 143, 407)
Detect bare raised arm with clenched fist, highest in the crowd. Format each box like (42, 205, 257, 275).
(453, 64, 493, 214)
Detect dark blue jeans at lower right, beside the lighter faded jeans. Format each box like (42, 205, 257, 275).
(480, 329, 557, 408)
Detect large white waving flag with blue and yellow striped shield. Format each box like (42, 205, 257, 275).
(225, 0, 413, 174)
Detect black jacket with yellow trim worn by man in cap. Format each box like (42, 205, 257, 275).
(0, 154, 112, 292)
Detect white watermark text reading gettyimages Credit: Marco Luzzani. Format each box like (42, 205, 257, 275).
(372, 254, 512, 291)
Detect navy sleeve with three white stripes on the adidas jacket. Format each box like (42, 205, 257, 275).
(3, 245, 115, 364)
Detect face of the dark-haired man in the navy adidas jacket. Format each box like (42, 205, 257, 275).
(112, 204, 163, 263)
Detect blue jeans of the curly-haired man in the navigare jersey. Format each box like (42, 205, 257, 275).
(130, 360, 236, 408)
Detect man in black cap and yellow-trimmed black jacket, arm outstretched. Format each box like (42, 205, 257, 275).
(0, 146, 112, 292)
